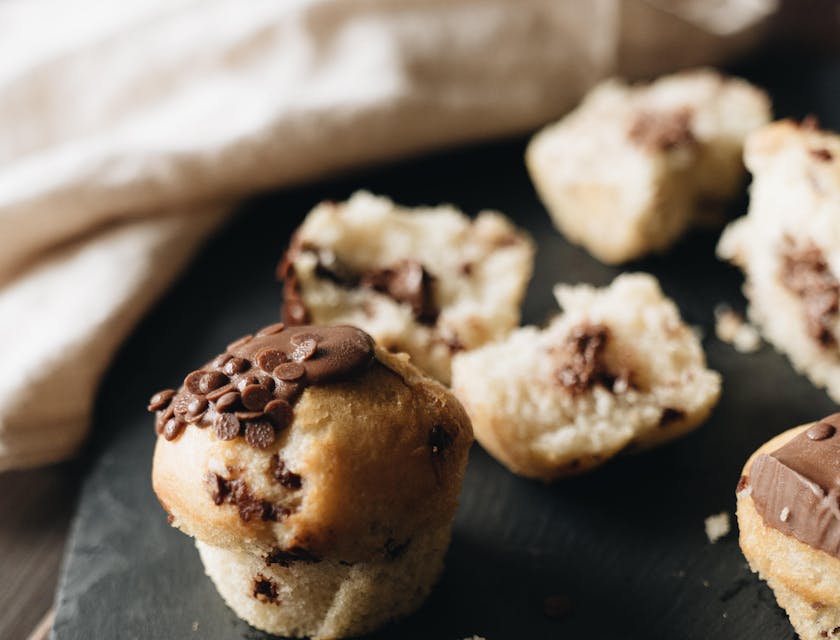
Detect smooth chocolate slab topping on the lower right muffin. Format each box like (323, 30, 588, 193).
(752, 413, 840, 558)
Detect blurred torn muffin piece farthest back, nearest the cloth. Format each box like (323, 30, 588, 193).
(526, 70, 771, 263)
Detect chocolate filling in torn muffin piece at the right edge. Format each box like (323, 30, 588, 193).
(779, 238, 840, 349)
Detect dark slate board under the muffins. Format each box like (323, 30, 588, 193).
(53, 51, 840, 640)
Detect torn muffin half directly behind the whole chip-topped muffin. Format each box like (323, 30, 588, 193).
(279, 192, 534, 383)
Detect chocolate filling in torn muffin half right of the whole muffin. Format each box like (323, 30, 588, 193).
(553, 324, 616, 393)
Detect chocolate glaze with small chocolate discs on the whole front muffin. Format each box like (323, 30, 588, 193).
(149, 324, 374, 449)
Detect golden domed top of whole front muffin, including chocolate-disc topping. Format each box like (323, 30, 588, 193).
(149, 324, 472, 562)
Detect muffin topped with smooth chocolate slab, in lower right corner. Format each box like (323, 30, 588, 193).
(737, 414, 840, 640)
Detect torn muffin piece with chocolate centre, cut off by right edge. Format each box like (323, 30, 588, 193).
(718, 121, 840, 402)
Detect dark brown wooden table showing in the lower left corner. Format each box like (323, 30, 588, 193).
(0, 463, 81, 640)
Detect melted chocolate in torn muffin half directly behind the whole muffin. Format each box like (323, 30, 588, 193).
(277, 239, 440, 326)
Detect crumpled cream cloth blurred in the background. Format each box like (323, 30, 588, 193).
(0, 0, 828, 469)
